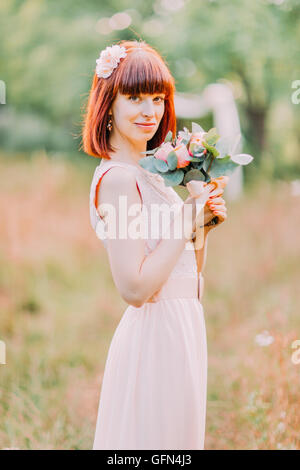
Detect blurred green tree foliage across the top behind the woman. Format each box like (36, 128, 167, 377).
(0, 0, 300, 177)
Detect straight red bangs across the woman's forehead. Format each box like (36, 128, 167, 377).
(116, 52, 174, 97)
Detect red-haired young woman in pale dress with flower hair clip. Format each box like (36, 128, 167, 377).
(83, 41, 226, 450)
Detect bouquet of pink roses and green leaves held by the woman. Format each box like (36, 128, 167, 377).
(139, 122, 253, 227)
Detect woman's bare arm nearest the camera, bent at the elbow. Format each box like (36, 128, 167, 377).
(98, 167, 211, 307)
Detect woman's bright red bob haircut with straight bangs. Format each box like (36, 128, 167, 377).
(80, 40, 176, 159)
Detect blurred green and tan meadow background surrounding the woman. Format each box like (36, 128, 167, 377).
(0, 0, 300, 449)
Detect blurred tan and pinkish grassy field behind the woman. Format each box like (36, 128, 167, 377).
(0, 152, 300, 449)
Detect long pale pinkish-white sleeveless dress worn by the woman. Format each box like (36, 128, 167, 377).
(90, 160, 207, 450)
